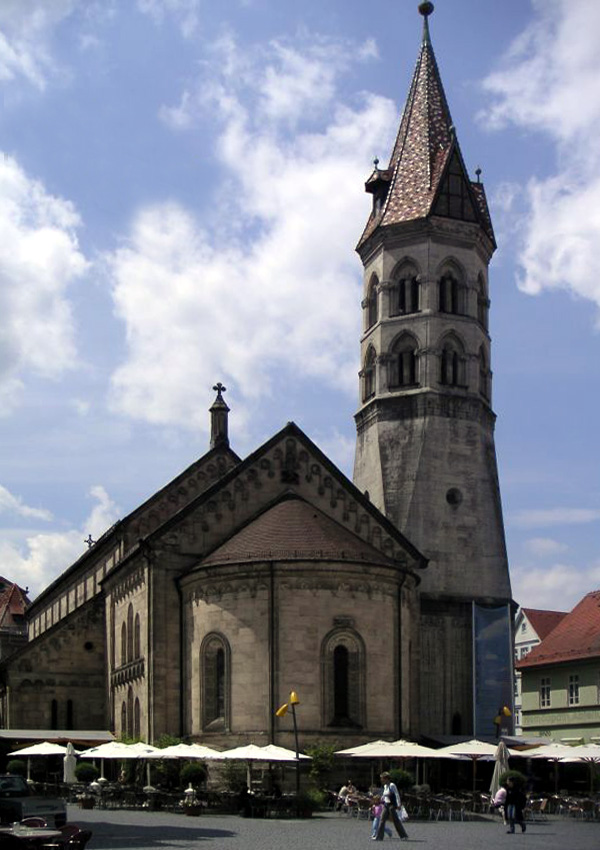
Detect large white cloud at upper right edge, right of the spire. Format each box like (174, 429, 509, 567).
(483, 0, 600, 314)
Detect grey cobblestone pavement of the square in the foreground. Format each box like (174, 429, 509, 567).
(69, 806, 600, 850)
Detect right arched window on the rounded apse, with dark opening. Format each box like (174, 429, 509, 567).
(321, 628, 365, 729)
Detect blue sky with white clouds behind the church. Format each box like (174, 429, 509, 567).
(0, 0, 600, 610)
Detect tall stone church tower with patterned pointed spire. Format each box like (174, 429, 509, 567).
(354, 2, 512, 735)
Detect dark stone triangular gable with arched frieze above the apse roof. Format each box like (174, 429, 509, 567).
(121, 422, 427, 569)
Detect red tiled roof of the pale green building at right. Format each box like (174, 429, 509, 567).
(517, 590, 600, 670)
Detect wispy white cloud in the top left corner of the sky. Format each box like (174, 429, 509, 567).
(0, 0, 78, 89)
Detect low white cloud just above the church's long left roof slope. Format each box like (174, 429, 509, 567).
(0, 486, 119, 596)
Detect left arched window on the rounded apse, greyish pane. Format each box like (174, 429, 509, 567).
(200, 634, 231, 730)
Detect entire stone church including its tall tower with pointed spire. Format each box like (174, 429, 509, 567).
(0, 2, 514, 748)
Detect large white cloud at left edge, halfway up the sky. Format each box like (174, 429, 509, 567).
(0, 156, 87, 414)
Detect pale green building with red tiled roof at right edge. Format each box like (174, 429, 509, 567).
(517, 590, 600, 743)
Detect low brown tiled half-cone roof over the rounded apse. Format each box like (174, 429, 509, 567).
(202, 498, 394, 566)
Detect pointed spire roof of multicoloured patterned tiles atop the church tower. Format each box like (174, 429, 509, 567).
(359, 11, 495, 247)
